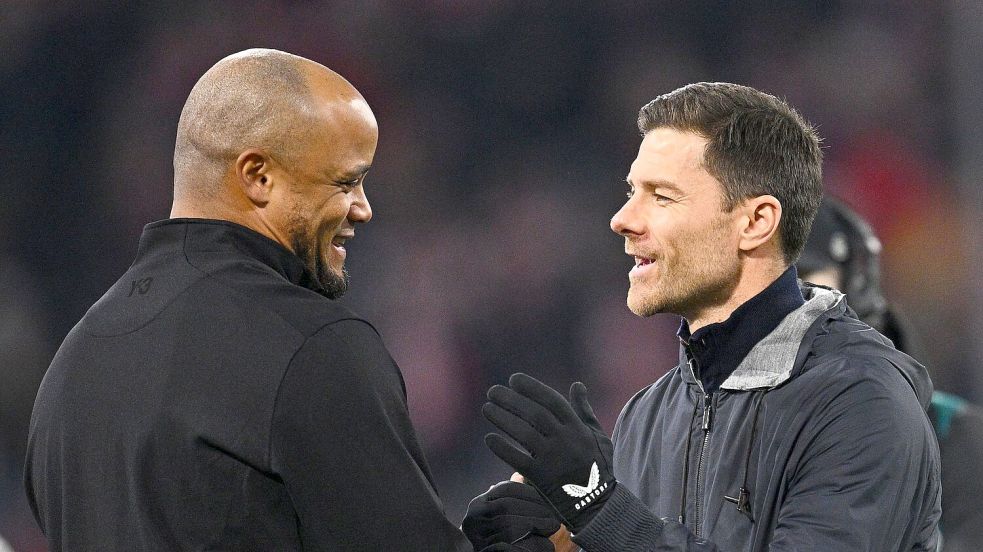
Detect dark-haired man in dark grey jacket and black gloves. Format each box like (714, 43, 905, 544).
(472, 83, 940, 552)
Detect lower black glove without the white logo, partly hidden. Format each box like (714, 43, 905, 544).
(461, 481, 560, 551)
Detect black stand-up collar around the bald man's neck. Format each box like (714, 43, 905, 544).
(137, 218, 323, 294)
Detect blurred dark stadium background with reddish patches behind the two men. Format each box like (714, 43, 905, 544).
(0, 0, 983, 551)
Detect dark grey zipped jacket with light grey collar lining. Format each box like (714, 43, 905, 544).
(574, 286, 941, 552)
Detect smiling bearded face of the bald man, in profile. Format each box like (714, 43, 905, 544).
(279, 98, 379, 298)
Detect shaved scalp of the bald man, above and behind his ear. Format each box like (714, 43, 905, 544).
(174, 49, 364, 201)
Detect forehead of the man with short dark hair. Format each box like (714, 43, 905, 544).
(628, 127, 709, 184)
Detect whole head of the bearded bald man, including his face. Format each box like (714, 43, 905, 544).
(171, 49, 379, 297)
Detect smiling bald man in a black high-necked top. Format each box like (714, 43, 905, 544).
(25, 50, 480, 551)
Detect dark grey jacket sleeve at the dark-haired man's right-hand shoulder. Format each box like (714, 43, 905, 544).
(771, 361, 941, 551)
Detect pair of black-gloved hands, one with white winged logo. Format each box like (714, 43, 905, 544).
(461, 374, 616, 552)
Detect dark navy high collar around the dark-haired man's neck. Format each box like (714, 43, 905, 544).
(676, 266, 805, 393)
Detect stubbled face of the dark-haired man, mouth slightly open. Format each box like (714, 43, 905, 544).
(611, 128, 740, 320)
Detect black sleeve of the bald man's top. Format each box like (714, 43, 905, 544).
(270, 320, 472, 552)
